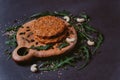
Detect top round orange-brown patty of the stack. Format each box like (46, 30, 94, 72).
(32, 16, 66, 38)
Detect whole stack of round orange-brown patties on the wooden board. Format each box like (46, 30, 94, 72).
(32, 16, 67, 44)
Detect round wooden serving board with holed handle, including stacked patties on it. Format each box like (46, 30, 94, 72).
(12, 16, 77, 62)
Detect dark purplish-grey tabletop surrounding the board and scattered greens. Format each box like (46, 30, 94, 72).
(0, 0, 120, 80)
